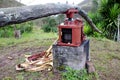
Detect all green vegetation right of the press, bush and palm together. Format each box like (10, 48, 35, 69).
(85, 0, 120, 39)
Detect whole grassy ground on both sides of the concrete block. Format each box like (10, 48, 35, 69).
(0, 29, 120, 80)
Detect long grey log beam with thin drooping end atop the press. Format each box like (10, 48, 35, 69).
(0, 4, 100, 32)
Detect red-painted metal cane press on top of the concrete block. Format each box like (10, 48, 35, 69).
(57, 9, 85, 46)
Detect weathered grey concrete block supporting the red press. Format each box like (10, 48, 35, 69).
(53, 40, 89, 70)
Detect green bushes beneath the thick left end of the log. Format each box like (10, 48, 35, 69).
(0, 22, 33, 38)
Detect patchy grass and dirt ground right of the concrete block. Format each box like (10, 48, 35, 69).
(90, 38, 120, 80)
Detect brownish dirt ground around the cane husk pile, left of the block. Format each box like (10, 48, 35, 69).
(0, 39, 60, 80)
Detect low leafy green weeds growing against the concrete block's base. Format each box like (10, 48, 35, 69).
(62, 67, 94, 80)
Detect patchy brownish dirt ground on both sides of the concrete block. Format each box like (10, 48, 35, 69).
(0, 38, 120, 80)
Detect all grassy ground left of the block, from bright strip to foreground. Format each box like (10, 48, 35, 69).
(0, 29, 57, 80)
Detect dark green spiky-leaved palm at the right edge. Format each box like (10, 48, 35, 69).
(99, 0, 120, 39)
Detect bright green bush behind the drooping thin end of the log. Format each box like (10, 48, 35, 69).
(84, 12, 105, 37)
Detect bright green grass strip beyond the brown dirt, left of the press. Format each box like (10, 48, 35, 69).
(0, 30, 57, 47)
